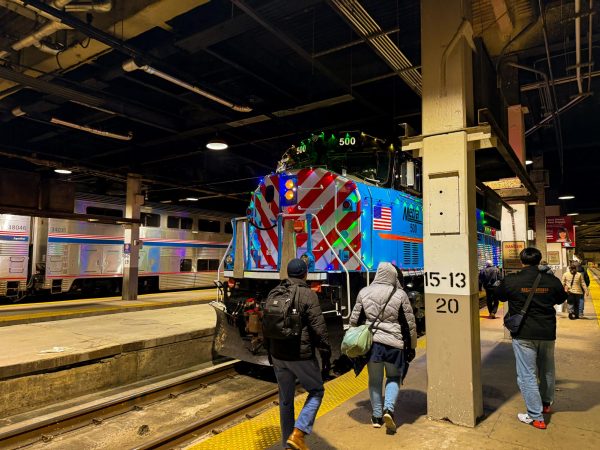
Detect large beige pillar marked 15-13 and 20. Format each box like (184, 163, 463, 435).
(421, 0, 483, 427)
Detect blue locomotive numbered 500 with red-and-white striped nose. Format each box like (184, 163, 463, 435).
(212, 132, 424, 365)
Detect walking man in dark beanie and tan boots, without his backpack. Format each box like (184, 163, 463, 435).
(266, 259, 331, 450)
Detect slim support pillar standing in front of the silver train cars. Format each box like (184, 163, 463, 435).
(123, 174, 144, 300)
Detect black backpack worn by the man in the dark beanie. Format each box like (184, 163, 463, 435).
(262, 280, 302, 339)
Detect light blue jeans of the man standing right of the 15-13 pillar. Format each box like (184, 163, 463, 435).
(513, 338, 555, 420)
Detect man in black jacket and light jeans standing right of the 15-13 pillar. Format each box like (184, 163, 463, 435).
(496, 247, 567, 430)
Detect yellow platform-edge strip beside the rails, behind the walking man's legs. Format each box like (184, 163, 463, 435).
(186, 370, 368, 450)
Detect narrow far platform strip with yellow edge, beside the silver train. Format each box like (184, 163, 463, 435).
(0, 289, 217, 327)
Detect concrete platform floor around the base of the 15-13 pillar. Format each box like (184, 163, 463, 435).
(272, 282, 600, 450)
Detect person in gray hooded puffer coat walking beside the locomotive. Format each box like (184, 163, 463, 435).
(350, 262, 417, 431)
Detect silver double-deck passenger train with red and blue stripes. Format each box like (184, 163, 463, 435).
(0, 194, 233, 297)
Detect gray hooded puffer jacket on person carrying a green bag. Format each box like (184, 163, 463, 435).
(350, 262, 417, 349)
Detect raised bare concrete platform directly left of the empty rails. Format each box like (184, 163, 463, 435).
(0, 304, 216, 419)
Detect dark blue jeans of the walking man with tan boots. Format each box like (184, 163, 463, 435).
(273, 358, 325, 448)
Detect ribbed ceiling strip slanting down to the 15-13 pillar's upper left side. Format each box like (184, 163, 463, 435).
(329, 0, 423, 97)
